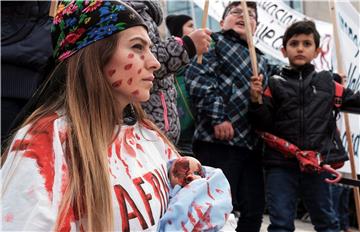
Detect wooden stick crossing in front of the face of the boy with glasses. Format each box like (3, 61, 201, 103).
(241, 0, 262, 104)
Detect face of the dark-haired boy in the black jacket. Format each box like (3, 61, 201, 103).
(281, 34, 320, 68)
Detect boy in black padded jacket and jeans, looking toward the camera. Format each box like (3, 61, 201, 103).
(250, 20, 360, 231)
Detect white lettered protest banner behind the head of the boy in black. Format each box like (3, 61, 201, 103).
(193, 0, 332, 70)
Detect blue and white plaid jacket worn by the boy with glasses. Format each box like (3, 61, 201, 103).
(185, 30, 276, 149)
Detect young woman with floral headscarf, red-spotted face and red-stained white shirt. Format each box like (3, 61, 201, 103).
(0, 1, 231, 231)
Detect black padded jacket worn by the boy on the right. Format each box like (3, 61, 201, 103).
(250, 64, 360, 167)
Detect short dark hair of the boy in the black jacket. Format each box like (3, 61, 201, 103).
(283, 20, 320, 49)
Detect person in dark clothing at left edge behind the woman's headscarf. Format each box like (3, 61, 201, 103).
(1, 1, 54, 142)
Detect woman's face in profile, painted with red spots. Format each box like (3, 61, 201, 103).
(104, 26, 160, 107)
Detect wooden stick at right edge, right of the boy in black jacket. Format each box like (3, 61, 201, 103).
(329, 0, 360, 231)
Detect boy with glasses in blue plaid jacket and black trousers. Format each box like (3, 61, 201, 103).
(185, 1, 275, 232)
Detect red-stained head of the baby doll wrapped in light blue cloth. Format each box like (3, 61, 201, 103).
(169, 156, 205, 187)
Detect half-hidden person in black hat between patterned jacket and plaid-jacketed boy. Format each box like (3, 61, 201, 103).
(165, 15, 195, 156)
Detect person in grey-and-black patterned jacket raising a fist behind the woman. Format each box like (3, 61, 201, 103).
(125, 0, 211, 144)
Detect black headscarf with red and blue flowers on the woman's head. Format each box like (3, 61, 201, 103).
(51, 0, 147, 61)
